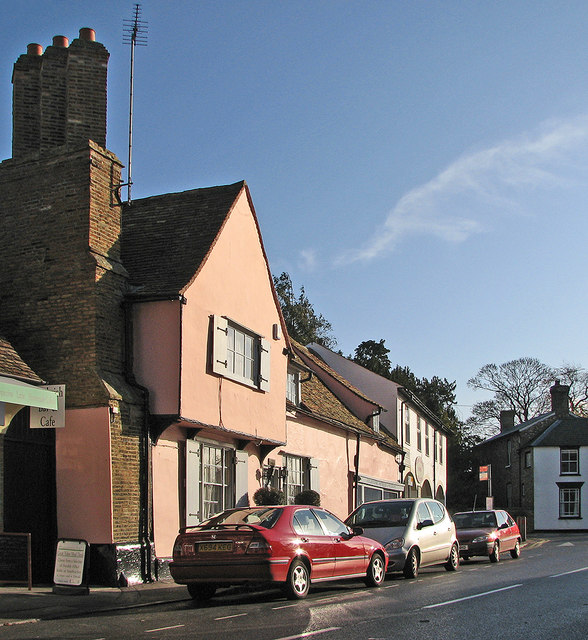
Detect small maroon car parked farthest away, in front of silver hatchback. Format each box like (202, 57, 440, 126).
(453, 509, 521, 562)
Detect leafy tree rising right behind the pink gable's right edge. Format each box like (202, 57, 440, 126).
(273, 272, 337, 349)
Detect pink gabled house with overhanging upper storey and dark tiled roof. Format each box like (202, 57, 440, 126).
(122, 182, 288, 558)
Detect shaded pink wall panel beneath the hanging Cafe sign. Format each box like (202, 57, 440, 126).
(55, 407, 114, 544)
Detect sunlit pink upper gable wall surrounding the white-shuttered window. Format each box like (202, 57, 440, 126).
(181, 191, 287, 440)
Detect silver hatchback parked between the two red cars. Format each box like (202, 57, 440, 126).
(345, 498, 459, 578)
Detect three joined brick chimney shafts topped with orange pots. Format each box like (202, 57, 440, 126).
(12, 28, 109, 158)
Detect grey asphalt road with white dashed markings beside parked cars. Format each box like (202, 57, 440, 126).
(1, 534, 588, 640)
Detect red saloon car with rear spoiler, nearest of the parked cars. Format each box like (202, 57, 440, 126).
(170, 505, 388, 600)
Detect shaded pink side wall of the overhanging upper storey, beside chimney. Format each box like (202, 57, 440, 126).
(133, 300, 181, 414)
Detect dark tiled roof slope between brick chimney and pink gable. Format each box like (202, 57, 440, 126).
(122, 181, 245, 296)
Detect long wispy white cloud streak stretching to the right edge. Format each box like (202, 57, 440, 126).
(336, 116, 588, 264)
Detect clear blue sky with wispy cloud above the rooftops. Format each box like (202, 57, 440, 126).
(0, 0, 588, 417)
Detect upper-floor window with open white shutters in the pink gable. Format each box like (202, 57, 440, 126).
(212, 315, 270, 391)
